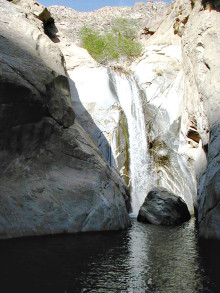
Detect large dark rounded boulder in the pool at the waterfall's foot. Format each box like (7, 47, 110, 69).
(137, 187, 190, 226)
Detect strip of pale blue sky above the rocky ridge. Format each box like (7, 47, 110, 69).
(39, 0, 170, 11)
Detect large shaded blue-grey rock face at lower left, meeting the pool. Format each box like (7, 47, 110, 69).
(0, 118, 130, 238)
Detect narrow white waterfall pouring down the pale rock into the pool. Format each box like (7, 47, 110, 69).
(110, 73, 150, 215)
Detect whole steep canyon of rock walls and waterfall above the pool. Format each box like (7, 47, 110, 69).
(0, 0, 220, 239)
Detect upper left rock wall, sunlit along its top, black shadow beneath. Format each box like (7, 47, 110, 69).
(0, 1, 75, 129)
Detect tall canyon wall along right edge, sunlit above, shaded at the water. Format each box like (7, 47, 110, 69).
(182, 1, 220, 239)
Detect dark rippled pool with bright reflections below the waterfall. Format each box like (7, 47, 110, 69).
(0, 219, 220, 293)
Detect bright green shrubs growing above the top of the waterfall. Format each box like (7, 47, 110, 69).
(80, 18, 142, 63)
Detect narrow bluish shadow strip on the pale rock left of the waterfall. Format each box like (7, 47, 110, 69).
(69, 78, 116, 167)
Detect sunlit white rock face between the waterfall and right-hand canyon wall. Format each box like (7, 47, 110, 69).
(131, 44, 198, 214)
